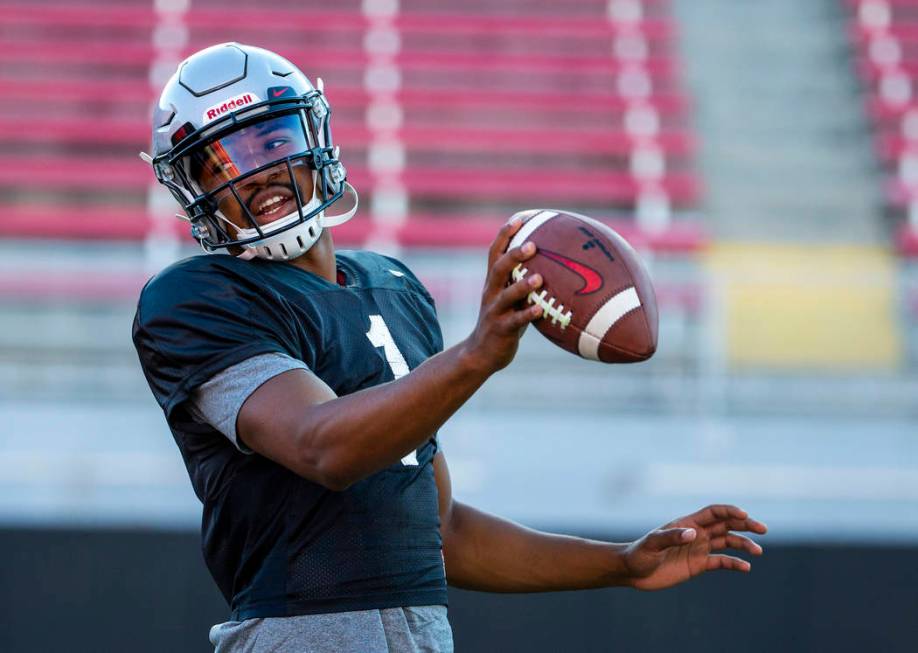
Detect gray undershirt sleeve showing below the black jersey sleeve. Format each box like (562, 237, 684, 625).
(188, 353, 309, 453)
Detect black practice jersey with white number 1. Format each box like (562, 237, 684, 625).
(134, 251, 446, 620)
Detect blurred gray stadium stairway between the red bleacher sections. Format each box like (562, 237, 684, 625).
(673, 0, 887, 244)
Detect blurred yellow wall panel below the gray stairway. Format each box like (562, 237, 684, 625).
(709, 243, 902, 371)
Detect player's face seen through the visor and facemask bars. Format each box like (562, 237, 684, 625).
(191, 115, 313, 229)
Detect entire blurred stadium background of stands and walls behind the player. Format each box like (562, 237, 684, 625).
(0, 0, 918, 652)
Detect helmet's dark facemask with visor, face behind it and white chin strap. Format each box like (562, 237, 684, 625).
(154, 91, 357, 260)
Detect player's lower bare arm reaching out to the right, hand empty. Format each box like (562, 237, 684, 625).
(434, 452, 766, 592)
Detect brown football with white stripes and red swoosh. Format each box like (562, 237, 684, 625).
(509, 209, 658, 363)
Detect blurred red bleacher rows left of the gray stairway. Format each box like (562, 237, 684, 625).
(0, 0, 703, 251)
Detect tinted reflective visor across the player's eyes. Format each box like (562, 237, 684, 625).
(183, 113, 310, 193)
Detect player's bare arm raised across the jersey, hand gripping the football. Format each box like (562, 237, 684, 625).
(236, 220, 542, 490)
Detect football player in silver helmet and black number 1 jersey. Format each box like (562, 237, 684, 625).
(133, 43, 765, 653)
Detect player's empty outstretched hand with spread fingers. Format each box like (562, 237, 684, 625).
(624, 505, 768, 590)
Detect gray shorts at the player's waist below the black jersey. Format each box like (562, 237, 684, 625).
(210, 605, 453, 653)
